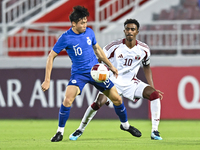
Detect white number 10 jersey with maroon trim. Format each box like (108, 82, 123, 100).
(103, 39, 150, 86)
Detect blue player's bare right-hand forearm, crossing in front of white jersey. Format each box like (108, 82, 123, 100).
(93, 43, 118, 77)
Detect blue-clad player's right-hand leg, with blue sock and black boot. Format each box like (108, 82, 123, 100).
(103, 86, 142, 137)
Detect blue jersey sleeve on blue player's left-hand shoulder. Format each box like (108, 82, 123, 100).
(53, 33, 68, 53)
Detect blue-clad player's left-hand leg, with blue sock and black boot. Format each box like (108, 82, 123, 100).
(51, 85, 80, 142)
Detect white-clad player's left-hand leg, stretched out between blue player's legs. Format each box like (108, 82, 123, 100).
(69, 92, 107, 141)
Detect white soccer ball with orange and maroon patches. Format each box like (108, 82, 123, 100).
(90, 63, 109, 83)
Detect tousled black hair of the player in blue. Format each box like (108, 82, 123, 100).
(69, 6, 89, 23)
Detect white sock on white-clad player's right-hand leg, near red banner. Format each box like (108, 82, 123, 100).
(151, 98, 161, 132)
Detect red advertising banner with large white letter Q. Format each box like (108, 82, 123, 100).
(152, 67, 200, 119)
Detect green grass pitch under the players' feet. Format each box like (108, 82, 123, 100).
(0, 119, 200, 150)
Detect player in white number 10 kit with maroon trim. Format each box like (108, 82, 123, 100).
(69, 19, 163, 140)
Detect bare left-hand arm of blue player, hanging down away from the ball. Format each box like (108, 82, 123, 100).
(41, 50, 58, 91)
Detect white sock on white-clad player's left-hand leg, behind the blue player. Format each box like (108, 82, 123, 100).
(78, 106, 97, 132)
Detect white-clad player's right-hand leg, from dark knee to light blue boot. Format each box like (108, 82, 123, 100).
(143, 86, 162, 140)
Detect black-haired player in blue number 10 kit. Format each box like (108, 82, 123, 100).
(41, 6, 141, 142)
